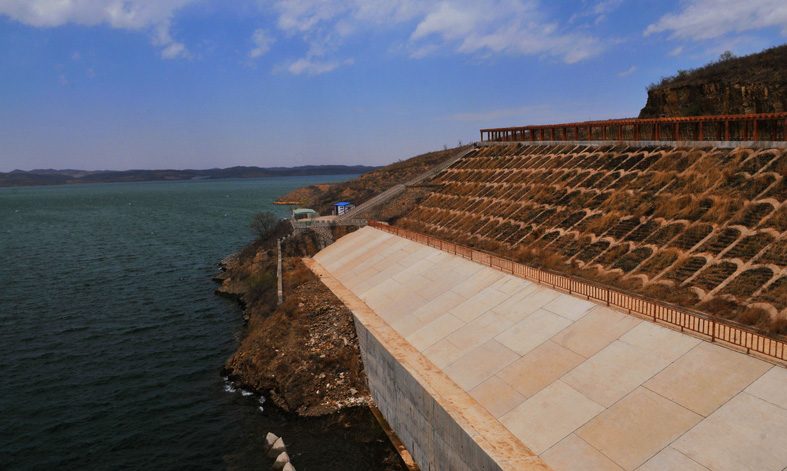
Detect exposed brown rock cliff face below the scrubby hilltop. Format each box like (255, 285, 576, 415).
(639, 81, 787, 118)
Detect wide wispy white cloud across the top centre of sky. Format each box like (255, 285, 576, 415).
(260, 0, 608, 72)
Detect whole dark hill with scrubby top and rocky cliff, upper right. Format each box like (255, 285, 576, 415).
(639, 44, 787, 118)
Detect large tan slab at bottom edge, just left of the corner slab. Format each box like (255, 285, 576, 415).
(577, 387, 702, 471)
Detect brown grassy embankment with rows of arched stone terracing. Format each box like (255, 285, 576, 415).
(398, 144, 787, 334)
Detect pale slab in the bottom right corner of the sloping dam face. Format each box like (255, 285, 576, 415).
(672, 393, 787, 471)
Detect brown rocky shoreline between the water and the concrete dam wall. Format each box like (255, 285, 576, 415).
(214, 225, 406, 471)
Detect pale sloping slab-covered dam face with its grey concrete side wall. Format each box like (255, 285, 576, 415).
(307, 227, 787, 471)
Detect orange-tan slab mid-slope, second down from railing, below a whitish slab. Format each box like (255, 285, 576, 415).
(497, 340, 585, 397)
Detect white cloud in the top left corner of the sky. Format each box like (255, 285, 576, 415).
(0, 0, 195, 59)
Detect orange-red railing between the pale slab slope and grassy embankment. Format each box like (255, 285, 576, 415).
(369, 220, 787, 361)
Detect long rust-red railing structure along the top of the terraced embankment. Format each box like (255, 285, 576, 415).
(481, 113, 787, 142)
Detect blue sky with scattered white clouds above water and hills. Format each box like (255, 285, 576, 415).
(0, 0, 787, 171)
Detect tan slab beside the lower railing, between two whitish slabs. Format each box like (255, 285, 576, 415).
(552, 306, 642, 358)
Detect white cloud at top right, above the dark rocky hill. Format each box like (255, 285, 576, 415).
(644, 0, 787, 40)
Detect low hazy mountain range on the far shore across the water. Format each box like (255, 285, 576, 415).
(0, 165, 379, 187)
